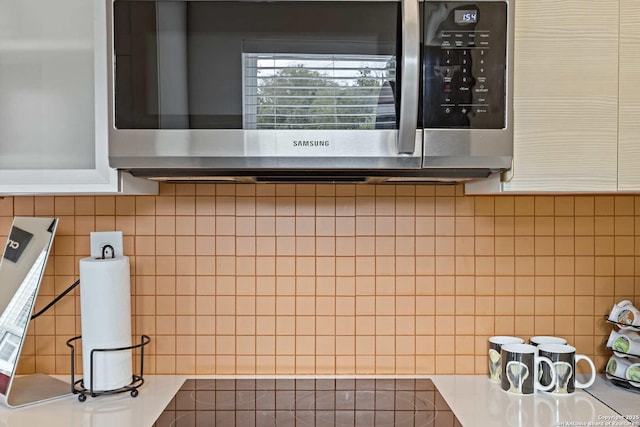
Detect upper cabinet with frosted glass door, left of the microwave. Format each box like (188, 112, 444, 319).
(0, 0, 157, 194)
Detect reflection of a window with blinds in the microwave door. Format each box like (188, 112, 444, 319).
(243, 51, 396, 130)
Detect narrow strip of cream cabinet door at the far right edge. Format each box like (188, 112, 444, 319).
(618, 0, 640, 191)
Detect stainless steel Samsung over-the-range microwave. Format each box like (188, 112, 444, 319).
(107, 0, 514, 182)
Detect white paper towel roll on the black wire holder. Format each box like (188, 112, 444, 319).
(80, 256, 132, 391)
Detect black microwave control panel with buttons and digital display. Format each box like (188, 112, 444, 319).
(422, 1, 508, 129)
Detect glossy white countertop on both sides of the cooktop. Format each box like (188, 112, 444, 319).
(0, 375, 640, 427)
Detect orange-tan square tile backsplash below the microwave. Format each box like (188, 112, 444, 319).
(0, 184, 640, 374)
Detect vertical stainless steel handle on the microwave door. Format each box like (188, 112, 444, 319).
(397, 0, 420, 154)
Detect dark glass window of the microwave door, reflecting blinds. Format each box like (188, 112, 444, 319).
(113, 0, 400, 130)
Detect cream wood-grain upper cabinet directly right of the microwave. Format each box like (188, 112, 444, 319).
(466, 0, 620, 194)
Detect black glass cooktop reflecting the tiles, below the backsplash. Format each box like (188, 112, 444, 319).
(154, 378, 462, 427)
